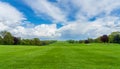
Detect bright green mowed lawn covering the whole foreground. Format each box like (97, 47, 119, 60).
(0, 42, 120, 69)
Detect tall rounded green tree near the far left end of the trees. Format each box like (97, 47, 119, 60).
(3, 32, 14, 45)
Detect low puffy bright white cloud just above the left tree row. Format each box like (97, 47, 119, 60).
(11, 24, 60, 39)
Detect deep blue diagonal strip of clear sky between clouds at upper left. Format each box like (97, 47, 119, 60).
(2, 0, 51, 25)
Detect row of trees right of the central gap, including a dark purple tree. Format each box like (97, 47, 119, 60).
(67, 32, 120, 44)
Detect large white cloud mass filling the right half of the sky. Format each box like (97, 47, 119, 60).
(41, 0, 120, 39)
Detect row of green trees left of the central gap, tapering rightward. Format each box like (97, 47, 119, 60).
(0, 31, 56, 46)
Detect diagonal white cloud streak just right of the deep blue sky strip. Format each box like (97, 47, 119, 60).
(25, 0, 66, 22)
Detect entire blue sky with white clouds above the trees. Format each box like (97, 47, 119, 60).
(0, 0, 120, 40)
